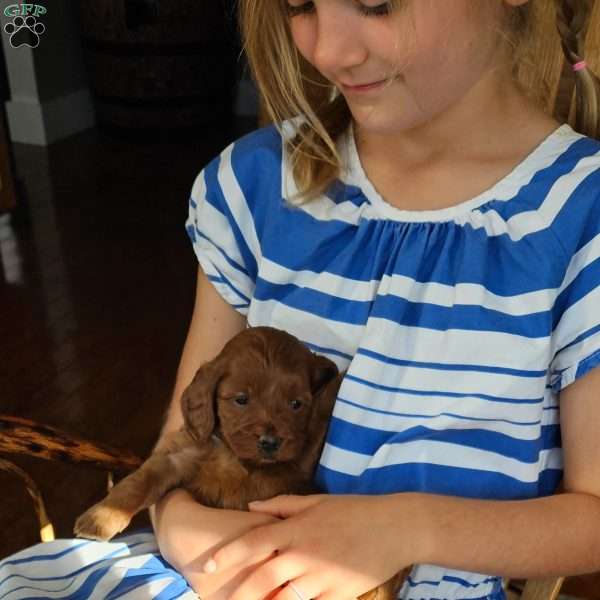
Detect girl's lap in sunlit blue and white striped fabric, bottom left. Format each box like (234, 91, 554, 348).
(0, 530, 198, 600)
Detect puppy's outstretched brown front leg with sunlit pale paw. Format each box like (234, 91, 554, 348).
(74, 434, 199, 541)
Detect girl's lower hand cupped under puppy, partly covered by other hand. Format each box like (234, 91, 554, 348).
(150, 490, 278, 600)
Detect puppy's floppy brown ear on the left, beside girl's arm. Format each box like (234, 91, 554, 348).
(181, 356, 224, 444)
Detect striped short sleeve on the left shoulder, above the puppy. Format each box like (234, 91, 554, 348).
(185, 145, 260, 315)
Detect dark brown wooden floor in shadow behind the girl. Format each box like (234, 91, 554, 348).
(0, 121, 600, 600)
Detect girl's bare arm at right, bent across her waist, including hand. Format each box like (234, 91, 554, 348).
(205, 368, 600, 600)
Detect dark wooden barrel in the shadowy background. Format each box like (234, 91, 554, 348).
(79, 0, 240, 139)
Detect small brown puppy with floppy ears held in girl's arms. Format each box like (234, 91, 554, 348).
(75, 327, 406, 600)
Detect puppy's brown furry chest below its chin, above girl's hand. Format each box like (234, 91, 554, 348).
(185, 445, 313, 510)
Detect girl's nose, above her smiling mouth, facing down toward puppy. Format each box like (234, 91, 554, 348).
(313, 9, 368, 77)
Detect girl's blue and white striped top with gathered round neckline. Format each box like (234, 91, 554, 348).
(186, 121, 600, 600)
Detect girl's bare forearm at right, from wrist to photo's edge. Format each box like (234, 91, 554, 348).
(396, 493, 600, 578)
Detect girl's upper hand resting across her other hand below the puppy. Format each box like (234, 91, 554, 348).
(204, 495, 415, 600)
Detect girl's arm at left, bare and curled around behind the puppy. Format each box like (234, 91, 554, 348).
(149, 268, 273, 600)
